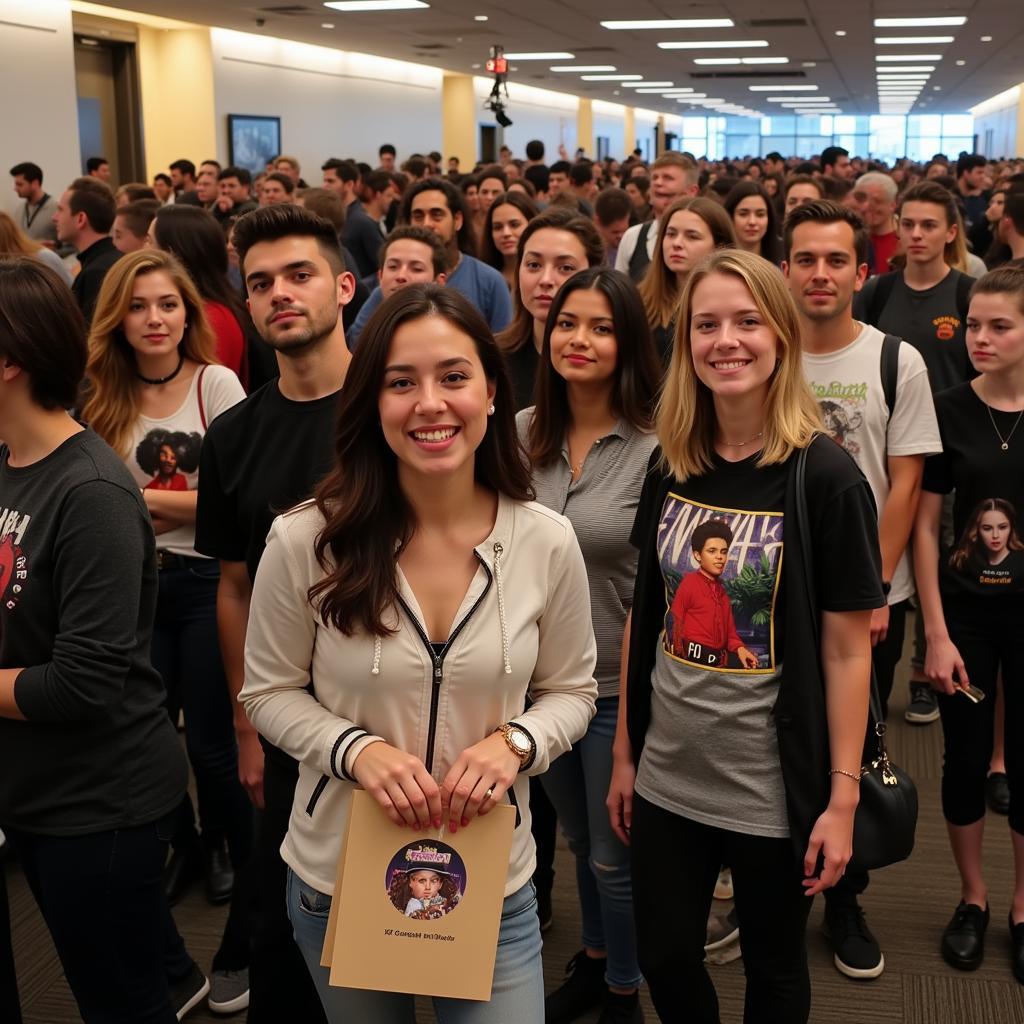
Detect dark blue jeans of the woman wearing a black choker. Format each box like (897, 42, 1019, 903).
(153, 558, 253, 867)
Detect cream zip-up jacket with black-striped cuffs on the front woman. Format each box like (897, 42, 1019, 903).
(239, 496, 597, 896)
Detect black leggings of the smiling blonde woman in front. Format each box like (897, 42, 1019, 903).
(630, 794, 811, 1024)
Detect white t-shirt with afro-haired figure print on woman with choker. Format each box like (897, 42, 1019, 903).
(126, 365, 246, 558)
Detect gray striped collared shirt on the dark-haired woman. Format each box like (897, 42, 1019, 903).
(516, 407, 657, 697)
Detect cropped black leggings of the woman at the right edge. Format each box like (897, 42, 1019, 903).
(939, 597, 1024, 835)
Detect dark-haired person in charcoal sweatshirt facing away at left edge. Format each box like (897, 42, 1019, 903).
(0, 258, 209, 1024)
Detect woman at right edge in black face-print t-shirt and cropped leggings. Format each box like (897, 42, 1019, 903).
(914, 267, 1024, 983)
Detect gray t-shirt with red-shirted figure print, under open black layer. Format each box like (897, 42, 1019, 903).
(636, 457, 790, 838)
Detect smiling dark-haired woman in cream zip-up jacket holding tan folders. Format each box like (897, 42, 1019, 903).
(241, 286, 597, 1024)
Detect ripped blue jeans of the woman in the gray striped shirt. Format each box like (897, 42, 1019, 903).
(541, 696, 641, 988)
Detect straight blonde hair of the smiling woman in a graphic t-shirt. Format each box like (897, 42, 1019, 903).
(656, 249, 822, 480)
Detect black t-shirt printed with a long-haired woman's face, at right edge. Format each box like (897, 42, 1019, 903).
(923, 384, 1024, 599)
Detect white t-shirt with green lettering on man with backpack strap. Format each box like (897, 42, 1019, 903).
(804, 324, 942, 604)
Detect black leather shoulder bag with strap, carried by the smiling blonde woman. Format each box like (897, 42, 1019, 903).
(796, 449, 918, 870)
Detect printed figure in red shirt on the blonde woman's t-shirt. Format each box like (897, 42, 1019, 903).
(670, 519, 759, 670)
